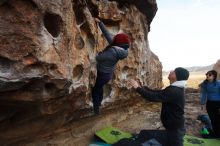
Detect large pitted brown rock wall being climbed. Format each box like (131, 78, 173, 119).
(0, 0, 162, 145)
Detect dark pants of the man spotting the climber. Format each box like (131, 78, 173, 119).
(138, 128, 186, 146)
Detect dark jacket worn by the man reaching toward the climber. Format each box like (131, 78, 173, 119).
(137, 86, 185, 130)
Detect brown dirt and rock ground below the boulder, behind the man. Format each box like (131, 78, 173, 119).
(27, 89, 204, 146)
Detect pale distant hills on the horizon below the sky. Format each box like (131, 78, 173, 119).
(163, 64, 214, 75)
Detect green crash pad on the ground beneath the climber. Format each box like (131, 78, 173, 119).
(95, 127, 132, 144)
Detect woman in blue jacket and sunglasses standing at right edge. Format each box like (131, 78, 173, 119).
(200, 70, 220, 138)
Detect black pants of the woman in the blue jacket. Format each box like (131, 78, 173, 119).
(206, 100, 220, 138)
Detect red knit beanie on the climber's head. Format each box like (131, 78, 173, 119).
(113, 33, 131, 45)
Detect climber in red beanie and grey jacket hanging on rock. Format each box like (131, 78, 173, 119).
(92, 18, 131, 114)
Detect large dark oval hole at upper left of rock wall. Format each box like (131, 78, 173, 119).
(44, 12, 63, 37)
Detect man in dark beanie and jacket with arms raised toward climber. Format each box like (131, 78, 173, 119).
(129, 67, 189, 146)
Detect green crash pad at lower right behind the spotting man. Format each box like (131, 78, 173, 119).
(184, 135, 220, 146)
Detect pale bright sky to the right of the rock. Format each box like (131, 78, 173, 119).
(148, 0, 220, 71)
